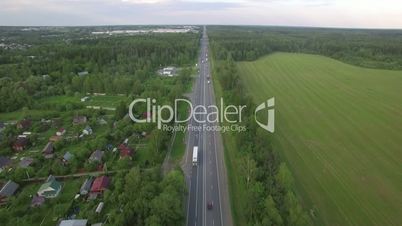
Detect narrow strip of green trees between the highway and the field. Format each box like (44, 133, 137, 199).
(214, 55, 312, 226)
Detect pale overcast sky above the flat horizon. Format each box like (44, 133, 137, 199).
(0, 0, 402, 28)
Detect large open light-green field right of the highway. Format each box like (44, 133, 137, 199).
(238, 53, 402, 225)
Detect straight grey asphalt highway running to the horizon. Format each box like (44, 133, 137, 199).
(184, 27, 233, 226)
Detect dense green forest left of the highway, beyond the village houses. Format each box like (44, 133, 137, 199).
(0, 33, 199, 112)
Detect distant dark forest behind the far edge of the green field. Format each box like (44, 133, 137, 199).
(208, 26, 402, 70)
